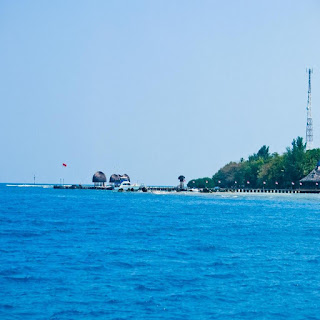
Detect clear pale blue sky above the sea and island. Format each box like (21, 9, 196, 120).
(0, 0, 320, 185)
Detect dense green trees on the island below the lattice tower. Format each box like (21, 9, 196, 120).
(188, 137, 320, 188)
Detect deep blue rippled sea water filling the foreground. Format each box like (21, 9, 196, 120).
(0, 184, 320, 320)
